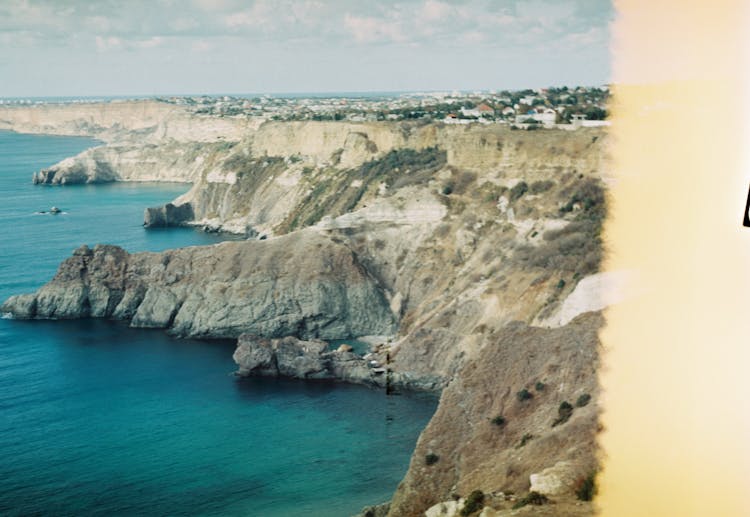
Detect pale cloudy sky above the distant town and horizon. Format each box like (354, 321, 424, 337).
(0, 0, 614, 97)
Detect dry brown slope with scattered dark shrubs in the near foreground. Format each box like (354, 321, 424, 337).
(390, 313, 603, 516)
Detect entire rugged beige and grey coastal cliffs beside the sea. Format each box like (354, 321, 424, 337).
(0, 103, 612, 516)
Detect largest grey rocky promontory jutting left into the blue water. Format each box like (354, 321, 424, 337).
(0, 233, 397, 339)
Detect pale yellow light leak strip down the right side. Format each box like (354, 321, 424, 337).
(596, 0, 750, 517)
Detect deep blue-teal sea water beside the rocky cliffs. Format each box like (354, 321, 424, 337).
(0, 132, 435, 516)
